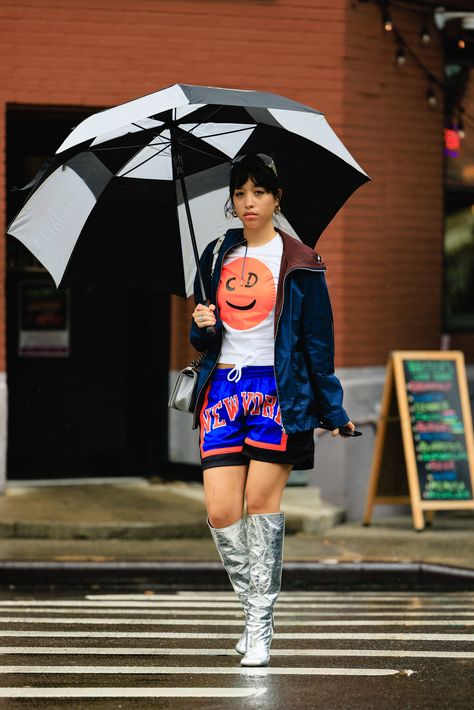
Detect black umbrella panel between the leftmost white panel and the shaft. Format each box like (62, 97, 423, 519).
(60, 178, 186, 296)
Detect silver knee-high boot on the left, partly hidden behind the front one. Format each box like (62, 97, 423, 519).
(207, 518, 249, 655)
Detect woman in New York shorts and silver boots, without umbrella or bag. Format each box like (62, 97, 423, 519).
(190, 153, 354, 666)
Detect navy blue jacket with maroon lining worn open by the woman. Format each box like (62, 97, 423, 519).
(190, 228, 349, 434)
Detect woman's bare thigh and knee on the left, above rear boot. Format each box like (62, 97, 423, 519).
(203, 465, 248, 528)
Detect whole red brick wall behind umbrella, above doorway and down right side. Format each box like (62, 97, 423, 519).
(0, 0, 466, 376)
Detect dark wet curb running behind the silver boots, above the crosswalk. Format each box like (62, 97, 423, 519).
(0, 561, 474, 591)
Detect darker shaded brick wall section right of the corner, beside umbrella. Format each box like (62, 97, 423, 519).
(337, 3, 443, 365)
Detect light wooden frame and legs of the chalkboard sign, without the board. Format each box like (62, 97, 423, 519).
(363, 350, 474, 531)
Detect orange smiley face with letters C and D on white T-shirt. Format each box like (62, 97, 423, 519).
(217, 257, 276, 330)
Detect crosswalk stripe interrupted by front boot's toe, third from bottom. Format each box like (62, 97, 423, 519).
(0, 646, 474, 659)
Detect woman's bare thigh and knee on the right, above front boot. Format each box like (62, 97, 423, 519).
(245, 460, 293, 515)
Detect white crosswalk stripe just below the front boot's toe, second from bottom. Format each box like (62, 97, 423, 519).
(0, 666, 413, 676)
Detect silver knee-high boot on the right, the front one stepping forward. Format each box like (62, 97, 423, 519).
(241, 513, 285, 666)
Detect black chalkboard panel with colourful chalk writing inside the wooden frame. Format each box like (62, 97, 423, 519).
(403, 359, 473, 501)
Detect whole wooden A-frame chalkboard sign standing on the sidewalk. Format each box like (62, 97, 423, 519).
(364, 351, 474, 530)
